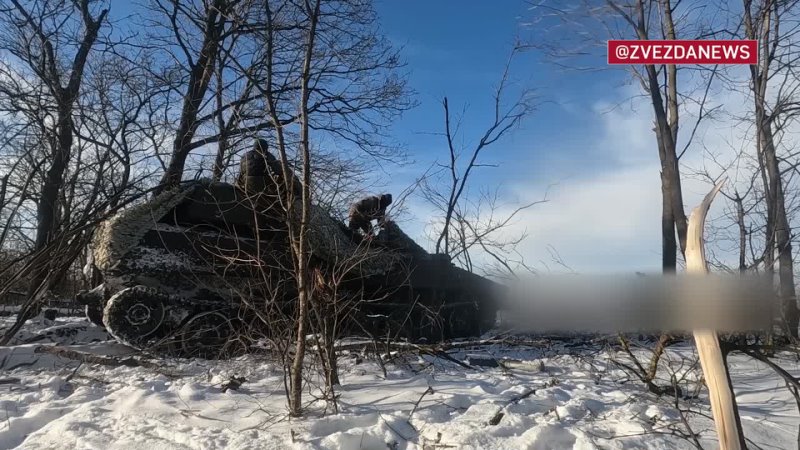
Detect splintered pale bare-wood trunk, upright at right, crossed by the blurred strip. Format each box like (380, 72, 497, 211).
(686, 180, 747, 450)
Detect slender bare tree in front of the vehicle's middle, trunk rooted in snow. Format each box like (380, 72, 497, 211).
(238, 0, 411, 415)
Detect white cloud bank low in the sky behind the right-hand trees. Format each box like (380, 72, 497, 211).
(400, 78, 776, 273)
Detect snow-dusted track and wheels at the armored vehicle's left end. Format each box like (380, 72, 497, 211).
(103, 286, 243, 358)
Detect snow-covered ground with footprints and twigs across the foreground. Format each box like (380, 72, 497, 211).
(0, 319, 800, 450)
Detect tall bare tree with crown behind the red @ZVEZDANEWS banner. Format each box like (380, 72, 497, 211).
(529, 0, 724, 272)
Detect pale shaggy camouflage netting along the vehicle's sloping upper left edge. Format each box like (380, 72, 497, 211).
(92, 184, 198, 271)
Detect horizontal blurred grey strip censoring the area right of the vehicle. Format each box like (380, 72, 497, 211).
(501, 275, 778, 333)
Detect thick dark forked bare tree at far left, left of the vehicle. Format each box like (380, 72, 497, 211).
(0, 0, 108, 330)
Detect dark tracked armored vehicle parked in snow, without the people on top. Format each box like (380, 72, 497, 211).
(79, 181, 498, 357)
